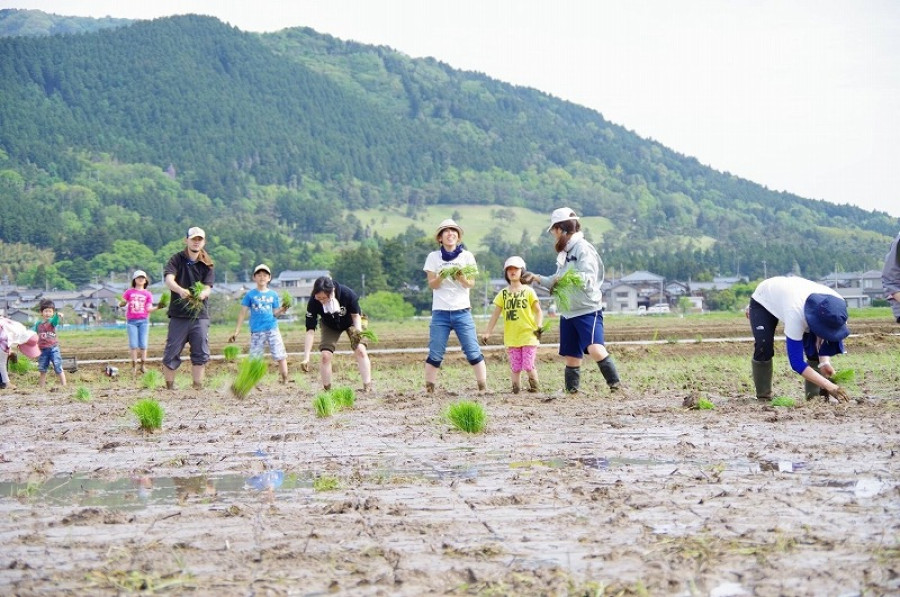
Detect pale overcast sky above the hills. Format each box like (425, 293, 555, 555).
(7, 0, 900, 217)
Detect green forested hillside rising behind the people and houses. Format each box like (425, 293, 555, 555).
(0, 11, 900, 304)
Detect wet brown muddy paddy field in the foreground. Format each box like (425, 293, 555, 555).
(0, 336, 900, 597)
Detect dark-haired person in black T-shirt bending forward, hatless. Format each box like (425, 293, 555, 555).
(300, 276, 372, 392)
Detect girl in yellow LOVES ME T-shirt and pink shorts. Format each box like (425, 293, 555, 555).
(481, 256, 544, 394)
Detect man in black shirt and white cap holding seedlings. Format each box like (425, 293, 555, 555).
(163, 226, 215, 390)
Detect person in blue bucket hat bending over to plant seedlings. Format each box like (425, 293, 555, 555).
(746, 276, 850, 402)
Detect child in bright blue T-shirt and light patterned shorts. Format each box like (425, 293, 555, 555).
(228, 263, 287, 383)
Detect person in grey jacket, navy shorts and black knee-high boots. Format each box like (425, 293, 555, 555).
(522, 207, 621, 394)
